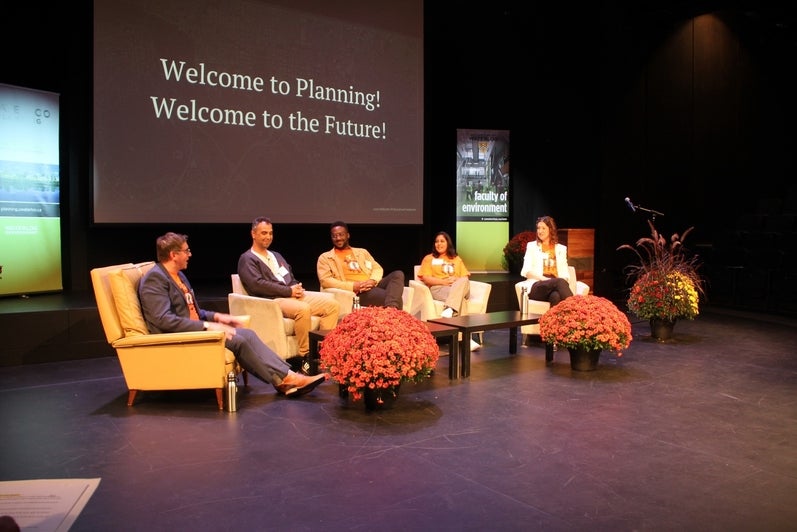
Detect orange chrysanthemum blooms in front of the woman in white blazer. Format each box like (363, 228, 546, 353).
(540, 295, 632, 355)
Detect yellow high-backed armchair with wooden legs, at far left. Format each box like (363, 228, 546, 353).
(91, 262, 247, 409)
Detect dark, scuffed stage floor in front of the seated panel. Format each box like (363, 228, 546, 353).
(0, 312, 797, 532)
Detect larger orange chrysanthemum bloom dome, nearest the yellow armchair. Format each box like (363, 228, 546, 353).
(320, 307, 440, 401)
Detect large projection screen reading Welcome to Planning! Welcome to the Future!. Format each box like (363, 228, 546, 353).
(92, 0, 423, 224)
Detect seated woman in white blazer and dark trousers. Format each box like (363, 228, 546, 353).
(520, 216, 573, 306)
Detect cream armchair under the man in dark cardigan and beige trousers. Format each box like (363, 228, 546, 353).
(227, 273, 332, 360)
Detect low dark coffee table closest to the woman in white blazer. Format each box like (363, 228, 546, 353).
(429, 310, 540, 378)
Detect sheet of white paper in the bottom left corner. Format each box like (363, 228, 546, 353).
(0, 478, 100, 532)
